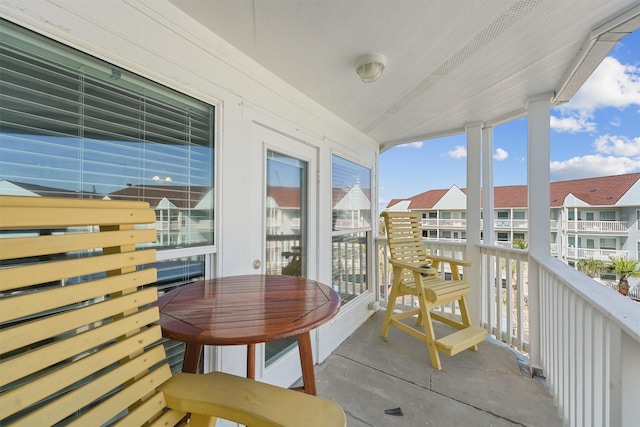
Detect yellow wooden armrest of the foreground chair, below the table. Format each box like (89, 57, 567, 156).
(159, 372, 347, 427)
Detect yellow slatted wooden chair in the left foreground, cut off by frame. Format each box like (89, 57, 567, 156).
(0, 196, 346, 427)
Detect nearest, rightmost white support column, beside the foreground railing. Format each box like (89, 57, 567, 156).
(527, 95, 551, 372)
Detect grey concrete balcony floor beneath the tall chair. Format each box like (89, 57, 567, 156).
(316, 311, 562, 427)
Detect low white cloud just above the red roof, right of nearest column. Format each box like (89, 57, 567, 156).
(550, 154, 640, 181)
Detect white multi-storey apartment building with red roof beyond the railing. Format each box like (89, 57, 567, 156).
(387, 173, 640, 265)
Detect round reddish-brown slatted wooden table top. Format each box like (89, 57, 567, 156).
(156, 274, 340, 345)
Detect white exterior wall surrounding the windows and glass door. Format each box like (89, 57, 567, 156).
(0, 0, 378, 392)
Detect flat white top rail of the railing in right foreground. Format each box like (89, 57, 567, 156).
(529, 254, 640, 343)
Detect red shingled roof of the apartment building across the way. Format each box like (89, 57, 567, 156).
(387, 173, 640, 210)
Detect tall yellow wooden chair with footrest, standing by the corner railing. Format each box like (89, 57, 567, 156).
(380, 211, 486, 370)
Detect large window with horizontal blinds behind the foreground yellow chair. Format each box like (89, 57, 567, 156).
(0, 22, 214, 249)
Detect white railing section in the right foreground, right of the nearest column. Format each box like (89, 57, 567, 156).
(529, 255, 640, 426)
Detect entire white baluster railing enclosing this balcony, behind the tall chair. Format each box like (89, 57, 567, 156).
(377, 239, 640, 426)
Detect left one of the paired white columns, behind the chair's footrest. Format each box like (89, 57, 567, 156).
(465, 122, 482, 325)
